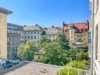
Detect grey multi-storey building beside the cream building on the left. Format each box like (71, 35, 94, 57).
(7, 23, 23, 58)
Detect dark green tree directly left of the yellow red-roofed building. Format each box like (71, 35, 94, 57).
(55, 33, 69, 49)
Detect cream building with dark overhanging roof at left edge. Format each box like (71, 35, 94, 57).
(0, 7, 12, 59)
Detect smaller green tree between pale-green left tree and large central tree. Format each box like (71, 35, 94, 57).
(37, 36, 51, 50)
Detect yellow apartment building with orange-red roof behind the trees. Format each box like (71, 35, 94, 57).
(64, 21, 89, 46)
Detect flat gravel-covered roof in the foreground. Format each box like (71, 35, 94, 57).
(4, 62, 62, 75)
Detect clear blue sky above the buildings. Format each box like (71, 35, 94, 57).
(0, 0, 91, 27)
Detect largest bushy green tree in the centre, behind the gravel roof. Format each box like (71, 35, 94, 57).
(40, 42, 69, 65)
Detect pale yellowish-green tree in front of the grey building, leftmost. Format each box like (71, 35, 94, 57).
(17, 40, 36, 61)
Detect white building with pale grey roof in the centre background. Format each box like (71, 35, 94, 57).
(44, 26, 63, 41)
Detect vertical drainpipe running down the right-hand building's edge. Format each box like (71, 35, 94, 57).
(90, 0, 95, 75)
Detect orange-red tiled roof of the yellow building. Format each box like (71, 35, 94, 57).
(64, 22, 89, 30)
